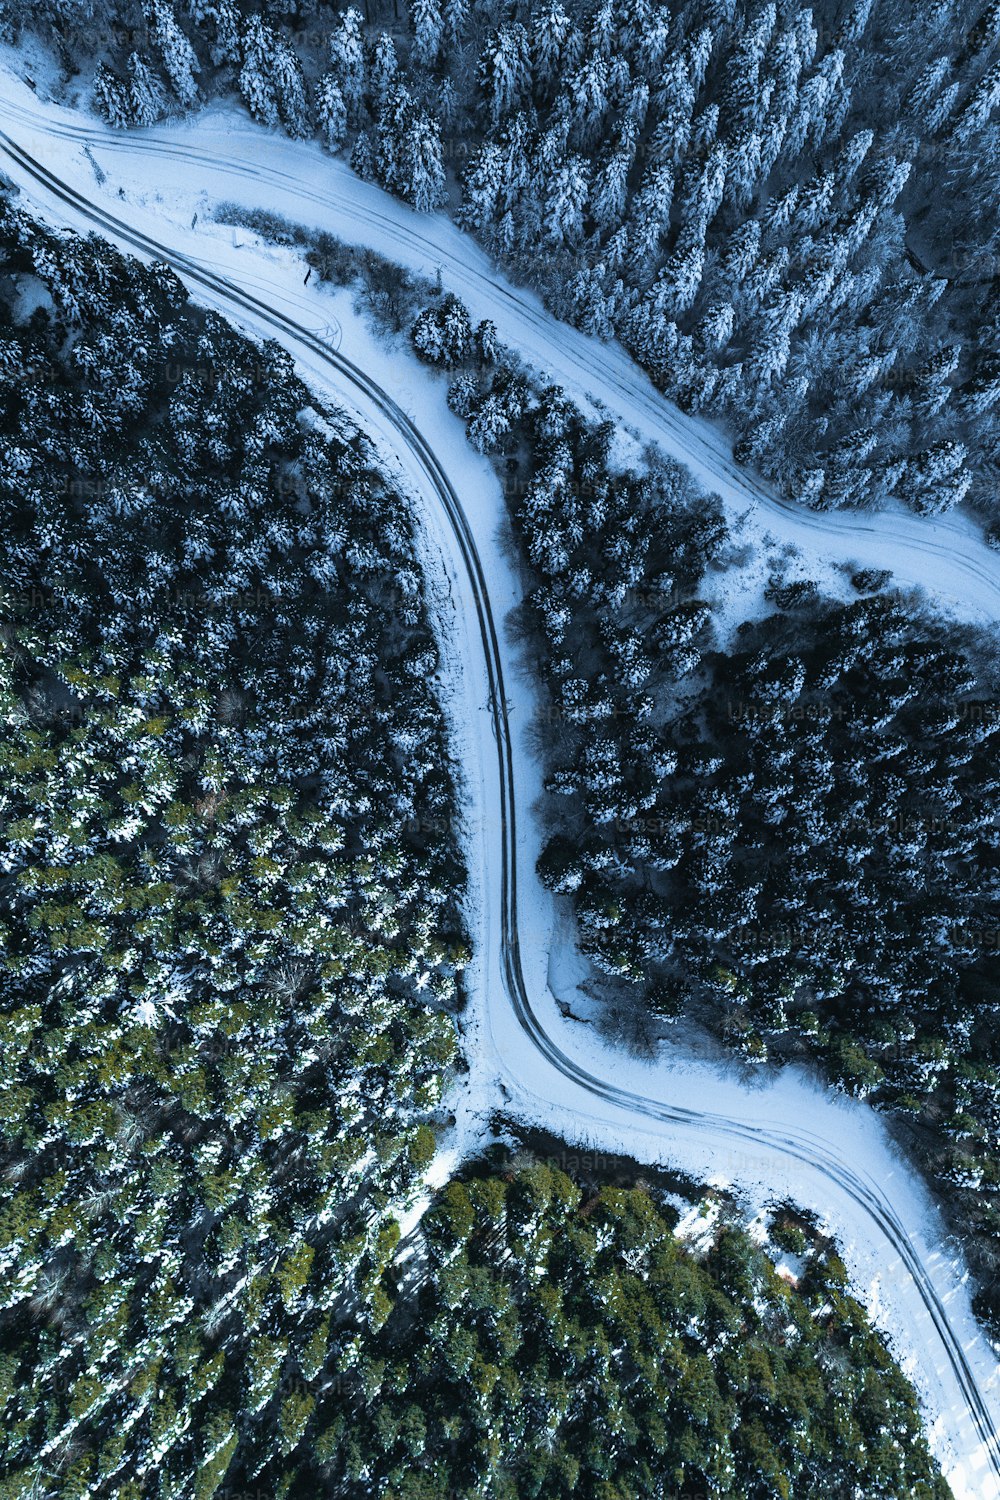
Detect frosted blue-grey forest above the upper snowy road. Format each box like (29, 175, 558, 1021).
(0, 0, 1000, 536)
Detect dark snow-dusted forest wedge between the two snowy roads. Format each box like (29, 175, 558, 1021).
(413, 298, 1000, 1328)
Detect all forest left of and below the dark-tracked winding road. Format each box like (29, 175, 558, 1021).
(0, 170, 949, 1500)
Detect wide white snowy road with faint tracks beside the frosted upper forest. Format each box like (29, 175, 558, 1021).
(0, 80, 1000, 621)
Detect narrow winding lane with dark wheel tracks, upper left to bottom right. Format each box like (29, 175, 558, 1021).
(0, 99, 1000, 1496)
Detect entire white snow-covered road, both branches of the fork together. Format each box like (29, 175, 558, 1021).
(0, 78, 1000, 1500)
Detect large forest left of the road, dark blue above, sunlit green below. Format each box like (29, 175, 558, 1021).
(0, 187, 468, 1497)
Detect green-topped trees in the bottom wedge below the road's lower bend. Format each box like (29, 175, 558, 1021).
(297, 1166, 949, 1500)
